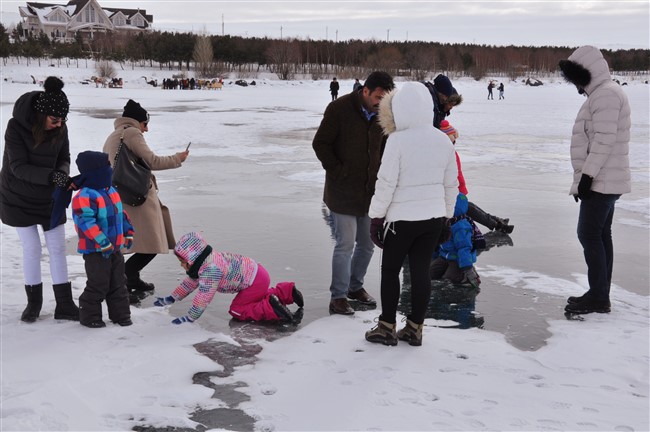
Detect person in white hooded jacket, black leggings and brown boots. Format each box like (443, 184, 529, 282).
(366, 82, 458, 346)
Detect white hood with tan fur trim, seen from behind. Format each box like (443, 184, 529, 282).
(378, 82, 433, 135)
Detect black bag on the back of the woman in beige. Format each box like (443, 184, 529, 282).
(113, 134, 151, 207)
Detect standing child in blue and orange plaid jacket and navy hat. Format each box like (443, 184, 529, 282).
(72, 151, 133, 328)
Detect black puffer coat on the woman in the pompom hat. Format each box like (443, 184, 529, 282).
(0, 91, 70, 231)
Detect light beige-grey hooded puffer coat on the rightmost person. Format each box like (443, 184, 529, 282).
(560, 46, 632, 195)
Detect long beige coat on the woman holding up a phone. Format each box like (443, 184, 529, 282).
(103, 117, 182, 254)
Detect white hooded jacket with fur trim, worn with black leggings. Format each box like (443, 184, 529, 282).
(368, 82, 458, 222)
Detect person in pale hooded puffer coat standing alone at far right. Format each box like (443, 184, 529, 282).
(560, 46, 632, 313)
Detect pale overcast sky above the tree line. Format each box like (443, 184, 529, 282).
(1, 0, 650, 49)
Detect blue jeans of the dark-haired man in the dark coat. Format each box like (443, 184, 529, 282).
(330, 212, 375, 299)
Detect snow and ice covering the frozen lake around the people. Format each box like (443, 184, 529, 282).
(0, 63, 650, 431)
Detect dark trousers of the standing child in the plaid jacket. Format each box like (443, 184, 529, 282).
(79, 251, 131, 325)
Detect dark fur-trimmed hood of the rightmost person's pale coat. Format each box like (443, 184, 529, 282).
(560, 45, 612, 95)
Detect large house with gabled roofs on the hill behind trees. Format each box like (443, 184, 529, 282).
(18, 0, 153, 42)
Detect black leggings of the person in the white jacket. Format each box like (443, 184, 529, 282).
(380, 218, 444, 324)
